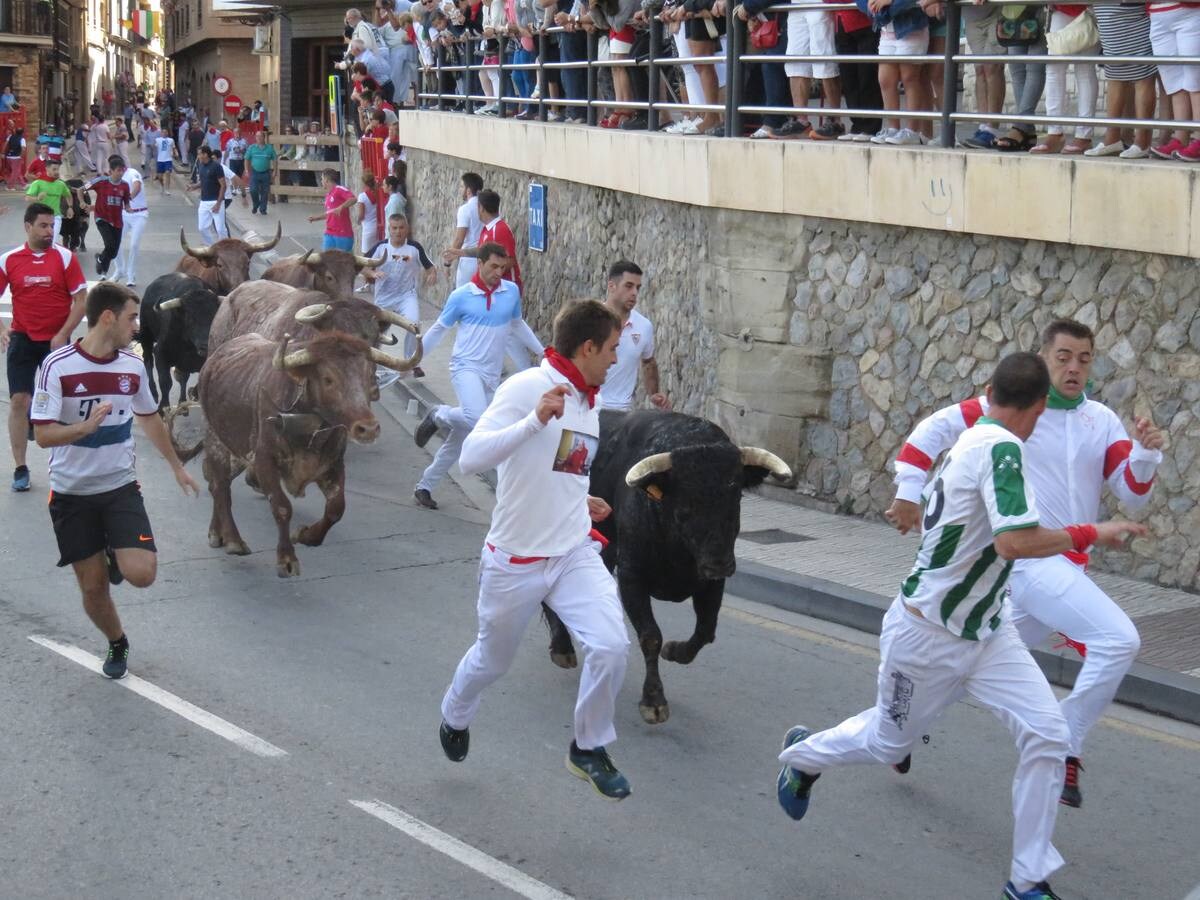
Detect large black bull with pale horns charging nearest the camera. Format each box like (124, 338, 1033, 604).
(545, 410, 792, 725)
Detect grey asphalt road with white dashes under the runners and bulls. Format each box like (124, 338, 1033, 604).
(0, 192, 1200, 900)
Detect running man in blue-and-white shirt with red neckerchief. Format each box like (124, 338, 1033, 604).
(413, 244, 545, 509)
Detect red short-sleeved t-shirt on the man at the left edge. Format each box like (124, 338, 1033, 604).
(0, 244, 88, 341)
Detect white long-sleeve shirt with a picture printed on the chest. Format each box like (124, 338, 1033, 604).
(458, 360, 600, 557)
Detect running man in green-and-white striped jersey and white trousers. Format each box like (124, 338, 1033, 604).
(776, 353, 1146, 900)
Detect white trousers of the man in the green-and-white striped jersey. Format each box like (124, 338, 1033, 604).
(779, 600, 1069, 883)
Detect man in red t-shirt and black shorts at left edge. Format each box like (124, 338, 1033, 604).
(0, 203, 88, 492)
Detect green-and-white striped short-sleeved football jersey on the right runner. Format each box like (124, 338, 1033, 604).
(900, 418, 1038, 641)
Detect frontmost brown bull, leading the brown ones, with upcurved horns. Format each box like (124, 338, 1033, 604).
(200, 334, 413, 578)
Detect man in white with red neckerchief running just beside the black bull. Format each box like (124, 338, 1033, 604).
(439, 300, 630, 800)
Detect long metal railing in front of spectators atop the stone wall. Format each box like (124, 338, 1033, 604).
(418, 0, 1200, 146)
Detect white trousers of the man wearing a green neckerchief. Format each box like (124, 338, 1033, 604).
(1009, 557, 1141, 756)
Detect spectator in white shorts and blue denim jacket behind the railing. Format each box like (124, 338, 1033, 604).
(857, 0, 929, 145)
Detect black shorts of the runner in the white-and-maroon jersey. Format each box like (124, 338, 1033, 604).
(50, 481, 158, 565)
